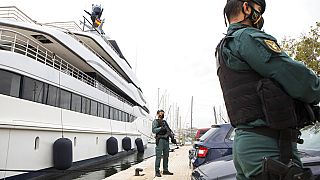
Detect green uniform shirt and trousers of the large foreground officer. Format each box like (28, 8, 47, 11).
(223, 23, 320, 179)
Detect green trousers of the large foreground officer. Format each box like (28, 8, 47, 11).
(232, 129, 302, 180)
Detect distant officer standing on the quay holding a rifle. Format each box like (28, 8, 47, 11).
(152, 110, 175, 177)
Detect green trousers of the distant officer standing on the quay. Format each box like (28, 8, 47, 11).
(155, 139, 169, 172)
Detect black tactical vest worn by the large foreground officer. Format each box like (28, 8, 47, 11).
(216, 30, 297, 129)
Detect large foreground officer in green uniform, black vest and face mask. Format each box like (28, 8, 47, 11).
(216, 0, 320, 179)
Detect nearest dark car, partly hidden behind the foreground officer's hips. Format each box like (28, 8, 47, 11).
(191, 123, 320, 180)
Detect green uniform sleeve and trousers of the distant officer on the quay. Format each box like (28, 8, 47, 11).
(152, 119, 169, 172)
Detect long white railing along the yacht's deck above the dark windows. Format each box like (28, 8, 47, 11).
(0, 28, 133, 106)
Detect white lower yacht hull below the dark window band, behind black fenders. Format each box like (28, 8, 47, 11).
(0, 95, 147, 178)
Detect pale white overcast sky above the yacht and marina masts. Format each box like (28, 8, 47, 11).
(0, 0, 320, 128)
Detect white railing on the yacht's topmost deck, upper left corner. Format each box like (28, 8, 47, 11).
(0, 6, 36, 24)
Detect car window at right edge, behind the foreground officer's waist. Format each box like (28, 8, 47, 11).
(298, 123, 320, 151)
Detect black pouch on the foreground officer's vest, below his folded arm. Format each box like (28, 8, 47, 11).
(257, 78, 297, 129)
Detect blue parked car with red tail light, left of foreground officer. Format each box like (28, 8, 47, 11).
(189, 124, 233, 168)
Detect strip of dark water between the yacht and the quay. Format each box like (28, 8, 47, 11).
(50, 144, 155, 180)
